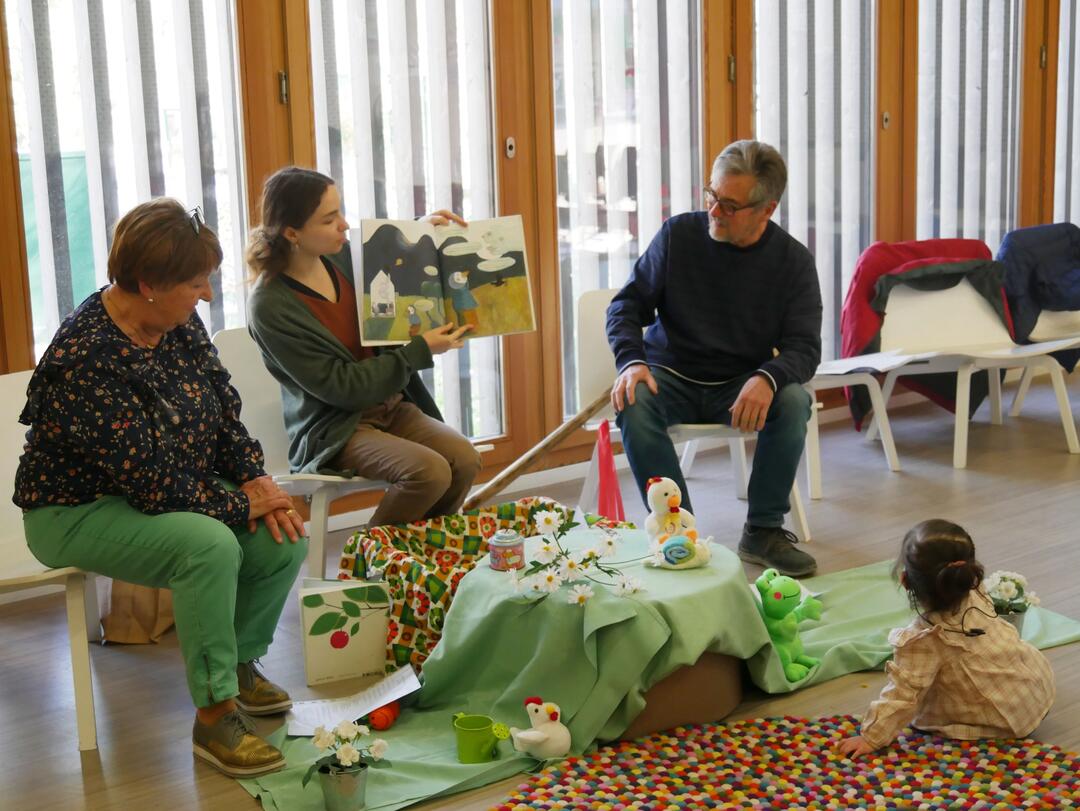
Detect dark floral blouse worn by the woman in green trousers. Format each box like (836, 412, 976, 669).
(13, 292, 264, 525)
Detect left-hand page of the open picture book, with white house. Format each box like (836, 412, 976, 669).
(350, 219, 444, 347)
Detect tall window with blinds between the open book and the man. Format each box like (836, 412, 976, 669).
(551, 0, 704, 414)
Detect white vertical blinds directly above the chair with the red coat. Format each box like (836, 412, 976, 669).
(916, 0, 1015, 252)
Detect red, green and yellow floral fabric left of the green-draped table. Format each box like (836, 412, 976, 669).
(337, 497, 633, 673)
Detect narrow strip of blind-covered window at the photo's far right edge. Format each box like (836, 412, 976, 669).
(1054, 2, 1080, 222)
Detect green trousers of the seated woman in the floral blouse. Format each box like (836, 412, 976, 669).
(23, 496, 308, 707)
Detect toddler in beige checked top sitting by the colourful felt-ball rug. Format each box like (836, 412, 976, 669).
(837, 519, 1054, 757)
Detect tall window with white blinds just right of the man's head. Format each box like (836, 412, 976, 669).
(754, 0, 875, 359)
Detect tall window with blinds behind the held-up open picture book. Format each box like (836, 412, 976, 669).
(308, 0, 503, 437)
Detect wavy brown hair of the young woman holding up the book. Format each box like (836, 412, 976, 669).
(245, 166, 334, 276)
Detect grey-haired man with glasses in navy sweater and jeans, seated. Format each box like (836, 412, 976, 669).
(607, 140, 822, 577)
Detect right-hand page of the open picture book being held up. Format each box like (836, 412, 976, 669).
(435, 216, 536, 338)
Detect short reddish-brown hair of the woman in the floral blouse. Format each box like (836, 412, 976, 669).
(109, 198, 224, 293)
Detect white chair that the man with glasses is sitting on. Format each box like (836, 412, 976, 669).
(577, 289, 818, 542)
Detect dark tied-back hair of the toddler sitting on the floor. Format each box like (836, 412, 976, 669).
(893, 518, 983, 613)
